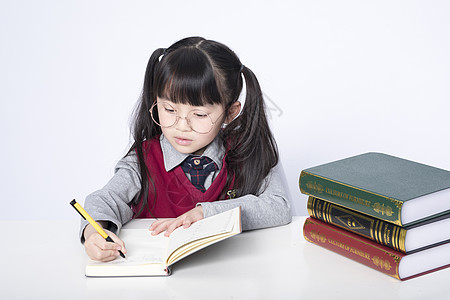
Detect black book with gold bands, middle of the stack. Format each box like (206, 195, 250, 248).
(308, 196, 450, 254)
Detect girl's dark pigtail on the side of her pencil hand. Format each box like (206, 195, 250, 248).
(128, 48, 165, 216)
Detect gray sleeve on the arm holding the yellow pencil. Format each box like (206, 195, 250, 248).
(80, 151, 141, 242)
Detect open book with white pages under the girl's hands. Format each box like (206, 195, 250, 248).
(86, 207, 242, 277)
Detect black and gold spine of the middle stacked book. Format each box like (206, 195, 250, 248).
(308, 196, 406, 253)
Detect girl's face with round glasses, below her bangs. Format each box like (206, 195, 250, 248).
(157, 98, 226, 155)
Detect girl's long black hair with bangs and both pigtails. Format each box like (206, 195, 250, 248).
(129, 37, 278, 215)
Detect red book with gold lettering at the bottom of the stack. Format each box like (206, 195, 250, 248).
(303, 217, 450, 280)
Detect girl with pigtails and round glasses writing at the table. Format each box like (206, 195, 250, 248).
(80, 37, 291, 261)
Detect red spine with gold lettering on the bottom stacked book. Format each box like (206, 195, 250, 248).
(303, 217, 405, 279)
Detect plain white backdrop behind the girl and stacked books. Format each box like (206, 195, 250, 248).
(0, 0, 450, 219)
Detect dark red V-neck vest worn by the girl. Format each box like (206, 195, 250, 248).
(132, 137, 233, 218)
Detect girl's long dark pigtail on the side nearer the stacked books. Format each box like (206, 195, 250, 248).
(223, 66, 278, 197)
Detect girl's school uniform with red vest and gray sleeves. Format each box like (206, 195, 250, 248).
(80, 135, 291, 242)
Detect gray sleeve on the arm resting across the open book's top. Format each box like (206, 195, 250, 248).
(198, 163, 292, 230)
